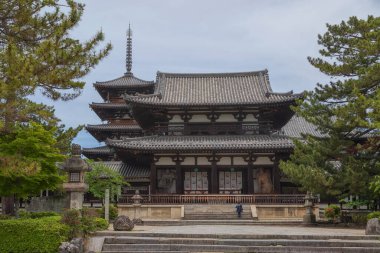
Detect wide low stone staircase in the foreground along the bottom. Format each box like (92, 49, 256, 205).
(102, 232, 380, 253)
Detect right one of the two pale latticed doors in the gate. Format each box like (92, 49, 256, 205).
(219, 169, 243, 194)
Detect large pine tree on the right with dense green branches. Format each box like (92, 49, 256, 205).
(280, 16, 380, 202)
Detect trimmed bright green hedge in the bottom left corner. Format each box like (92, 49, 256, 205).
(0, 217, 69, 253)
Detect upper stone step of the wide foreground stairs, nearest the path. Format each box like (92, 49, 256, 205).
(104, 237, 380, 248)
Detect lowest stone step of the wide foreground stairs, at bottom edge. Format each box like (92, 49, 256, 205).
(102, 244, 379, 253)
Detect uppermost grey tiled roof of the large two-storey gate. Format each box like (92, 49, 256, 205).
(124, 70, 301, 106)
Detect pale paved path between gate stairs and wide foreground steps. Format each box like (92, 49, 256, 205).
(128, 225, 365, 236)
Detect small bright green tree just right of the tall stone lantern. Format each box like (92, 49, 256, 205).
(85, 161, 129, 199)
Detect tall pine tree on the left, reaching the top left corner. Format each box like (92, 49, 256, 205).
(0, 0, 111, 214)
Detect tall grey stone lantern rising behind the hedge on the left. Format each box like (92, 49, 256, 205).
(62, 144, 91, 209)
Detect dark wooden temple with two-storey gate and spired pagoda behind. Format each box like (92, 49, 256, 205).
(82, 26, 319, 199)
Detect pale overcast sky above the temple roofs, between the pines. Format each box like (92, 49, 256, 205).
(34, 0, 380, 147)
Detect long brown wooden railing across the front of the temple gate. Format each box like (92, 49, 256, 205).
(119, 194, 318, 205)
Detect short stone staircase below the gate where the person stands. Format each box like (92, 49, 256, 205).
(184, 204, 253, 221)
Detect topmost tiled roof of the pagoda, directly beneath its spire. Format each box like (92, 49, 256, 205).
(94, 74, 154, 89)
